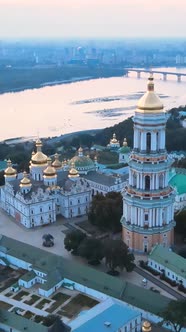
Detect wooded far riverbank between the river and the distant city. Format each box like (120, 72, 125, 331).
(0, 65, 125, 94)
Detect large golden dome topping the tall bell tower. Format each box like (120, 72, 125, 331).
(137, 74, 163, 113)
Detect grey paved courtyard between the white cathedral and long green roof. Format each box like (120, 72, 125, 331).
(0, 209, 176, 298)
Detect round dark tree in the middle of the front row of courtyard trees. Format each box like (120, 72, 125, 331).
(78, 238, 104, 265)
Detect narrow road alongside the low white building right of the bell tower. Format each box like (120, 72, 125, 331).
(134, 266, 185, 300)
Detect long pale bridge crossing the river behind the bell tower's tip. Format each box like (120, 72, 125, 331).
(125, 68, 186, 82)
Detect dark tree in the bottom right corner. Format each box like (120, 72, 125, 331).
(161, 299, 186, 332)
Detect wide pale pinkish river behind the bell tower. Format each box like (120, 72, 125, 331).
(0, 68, 186, 140)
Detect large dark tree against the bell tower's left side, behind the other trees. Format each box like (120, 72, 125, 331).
(88, 192, 123, 232)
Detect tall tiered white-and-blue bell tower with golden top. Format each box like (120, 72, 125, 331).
(121, 76, 175, 252)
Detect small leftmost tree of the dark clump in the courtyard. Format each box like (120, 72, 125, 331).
(64, 230, 86, 255)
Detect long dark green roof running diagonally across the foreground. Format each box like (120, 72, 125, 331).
(0, 235, 170, 314)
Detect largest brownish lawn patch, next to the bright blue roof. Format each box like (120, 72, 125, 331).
(62, 294, 99, 318)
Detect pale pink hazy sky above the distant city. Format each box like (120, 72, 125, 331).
(0, 0, 186, 38)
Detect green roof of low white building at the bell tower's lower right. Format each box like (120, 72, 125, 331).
(149, 245, 186, 278)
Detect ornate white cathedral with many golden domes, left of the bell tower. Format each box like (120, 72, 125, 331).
(0, 139, 127, 228)
